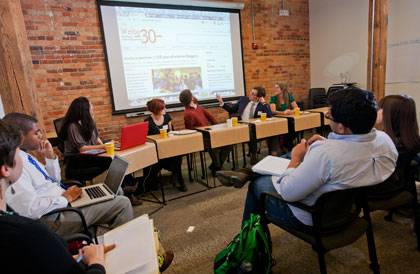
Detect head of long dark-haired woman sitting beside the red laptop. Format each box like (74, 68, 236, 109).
(59, 96, 96, 140)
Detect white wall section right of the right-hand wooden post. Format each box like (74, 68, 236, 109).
(385, 0, 420, 121)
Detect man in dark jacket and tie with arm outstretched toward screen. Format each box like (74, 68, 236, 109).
(216, 87, 280, 164)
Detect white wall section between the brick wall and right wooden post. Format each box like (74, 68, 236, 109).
(309, 0, 369, 88)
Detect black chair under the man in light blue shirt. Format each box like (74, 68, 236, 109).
(261, 188, 379, 273)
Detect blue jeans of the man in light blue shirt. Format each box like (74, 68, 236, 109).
(242, 175, 311, 231)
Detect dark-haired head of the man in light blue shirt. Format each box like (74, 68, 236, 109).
(328, 87, 377, 134)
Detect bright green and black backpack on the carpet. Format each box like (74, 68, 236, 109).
(214, 214, 271, 274)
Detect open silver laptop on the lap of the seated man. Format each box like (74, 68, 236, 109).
(71, 156, 128, 207)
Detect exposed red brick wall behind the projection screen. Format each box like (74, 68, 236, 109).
(21, 0, 310, 139)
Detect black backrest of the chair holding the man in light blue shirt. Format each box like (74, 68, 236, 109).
(312, 188, 362, 234)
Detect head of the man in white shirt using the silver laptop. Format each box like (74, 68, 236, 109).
(3, 112, 42, 150)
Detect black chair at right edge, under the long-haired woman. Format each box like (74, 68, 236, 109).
(368, 151, 420, 251)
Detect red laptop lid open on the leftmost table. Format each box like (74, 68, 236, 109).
(119, 122, 149, 150)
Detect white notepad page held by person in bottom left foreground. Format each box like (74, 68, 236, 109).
(103, 215, 159, 274)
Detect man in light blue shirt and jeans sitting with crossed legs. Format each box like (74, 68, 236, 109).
(226, 87, 398, 229)
